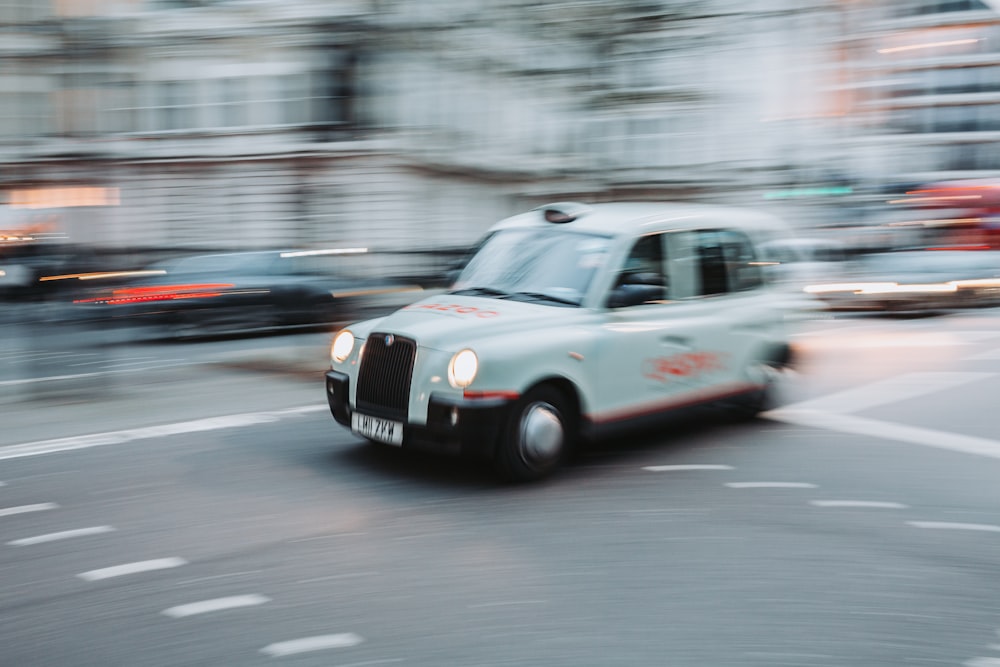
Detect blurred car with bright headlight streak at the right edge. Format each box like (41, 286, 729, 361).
(805, 250, 1000, 312)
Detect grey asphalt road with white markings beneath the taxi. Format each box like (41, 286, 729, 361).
(0, 311, 1000, 667)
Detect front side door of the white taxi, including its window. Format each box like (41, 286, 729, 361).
(592, 233, 716, 426)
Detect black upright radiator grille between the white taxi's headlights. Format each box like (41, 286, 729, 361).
(357, 333, 417, 421)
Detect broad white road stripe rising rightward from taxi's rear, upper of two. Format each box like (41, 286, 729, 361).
(773, 372, 997, 413)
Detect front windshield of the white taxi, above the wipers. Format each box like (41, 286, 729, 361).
(452, 228, 611, 306)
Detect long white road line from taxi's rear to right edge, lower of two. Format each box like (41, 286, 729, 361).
(763, 408, 1000, 459)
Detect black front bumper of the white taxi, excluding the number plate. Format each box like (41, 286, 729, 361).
(326, 370, 513, 459)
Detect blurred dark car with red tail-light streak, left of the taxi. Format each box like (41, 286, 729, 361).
(74, 251, 421, 339)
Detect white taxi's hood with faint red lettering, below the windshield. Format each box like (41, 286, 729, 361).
(364, 294, 586, 350)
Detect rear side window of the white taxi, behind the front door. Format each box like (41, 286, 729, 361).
(668, 229, 763, 299)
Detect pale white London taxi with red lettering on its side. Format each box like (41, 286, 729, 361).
(326, 203, 804, 481)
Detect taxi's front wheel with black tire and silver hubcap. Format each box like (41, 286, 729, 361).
(494, 385, 577, 482)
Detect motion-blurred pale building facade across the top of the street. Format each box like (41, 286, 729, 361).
(0, 0, 1000, 260)
